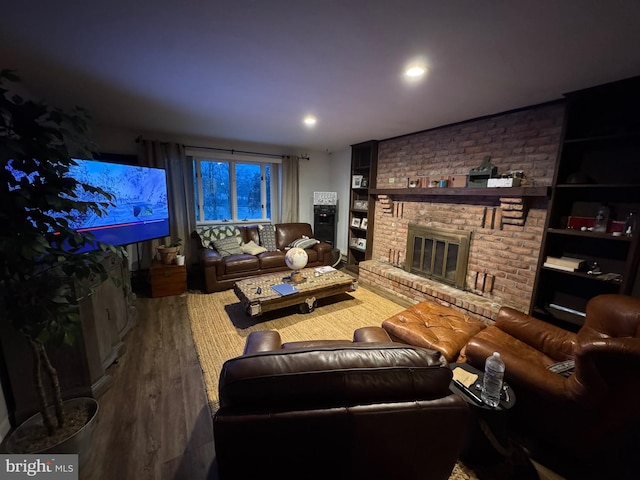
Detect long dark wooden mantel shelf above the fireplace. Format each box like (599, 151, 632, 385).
(369, 187, 550, 197)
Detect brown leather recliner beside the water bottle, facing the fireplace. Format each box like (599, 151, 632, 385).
(465, 295, 640, 473)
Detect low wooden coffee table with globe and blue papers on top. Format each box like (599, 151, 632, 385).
(233, 268, 358, 317)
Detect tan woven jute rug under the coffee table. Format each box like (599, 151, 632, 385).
(187, 288, 478, 480)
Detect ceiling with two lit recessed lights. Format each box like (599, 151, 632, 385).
(0, 0, 640, 152)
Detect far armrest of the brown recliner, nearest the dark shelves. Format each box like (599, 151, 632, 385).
(496, 307, 577, 360)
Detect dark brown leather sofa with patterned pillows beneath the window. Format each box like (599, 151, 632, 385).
(191, 223, 333, 293)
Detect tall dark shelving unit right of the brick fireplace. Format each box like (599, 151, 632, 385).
(532, 77, 640, 329)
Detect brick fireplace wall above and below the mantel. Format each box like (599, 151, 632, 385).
(372, 104, 564, 311)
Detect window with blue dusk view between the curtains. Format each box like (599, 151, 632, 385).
(193, 158, 277, 223)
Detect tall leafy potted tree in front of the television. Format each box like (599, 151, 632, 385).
(0, 70, 123, 462)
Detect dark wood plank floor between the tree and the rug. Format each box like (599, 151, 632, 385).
(80, 296, 216, 480)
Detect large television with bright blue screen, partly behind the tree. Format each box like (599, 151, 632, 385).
(68, 159, 169, 249)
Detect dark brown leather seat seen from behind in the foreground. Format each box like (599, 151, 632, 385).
(214, 327, 469, 480)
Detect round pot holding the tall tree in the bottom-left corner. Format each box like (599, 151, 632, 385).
(5, 397, 99, 468)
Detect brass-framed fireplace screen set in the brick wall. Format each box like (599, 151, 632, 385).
(405, 225, 471, 289)
